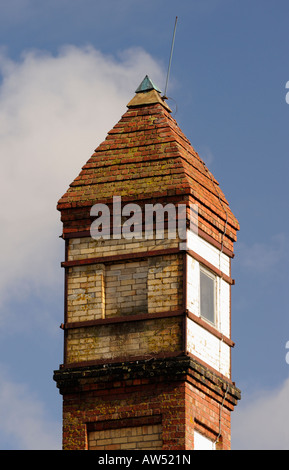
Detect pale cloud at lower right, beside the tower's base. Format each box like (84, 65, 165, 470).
(232, 379, 289, 450)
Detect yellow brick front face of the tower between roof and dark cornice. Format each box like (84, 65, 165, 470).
(65, 233, 183, 365)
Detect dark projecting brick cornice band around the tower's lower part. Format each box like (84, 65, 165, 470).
(53, 356, 241, 407)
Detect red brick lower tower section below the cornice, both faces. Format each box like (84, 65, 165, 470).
(57, 360, 236, 450)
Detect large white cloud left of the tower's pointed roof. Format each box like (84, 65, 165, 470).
(0, 46, 164, 310)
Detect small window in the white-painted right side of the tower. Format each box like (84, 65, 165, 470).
(200, 267, 216, 323)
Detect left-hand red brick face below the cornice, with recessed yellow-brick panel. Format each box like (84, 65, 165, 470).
(63, 379, 185, 450)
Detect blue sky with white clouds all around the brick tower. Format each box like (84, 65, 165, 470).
(0, 0, 289, 450)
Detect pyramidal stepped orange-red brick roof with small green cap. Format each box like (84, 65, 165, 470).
(57, 77, 239, 251)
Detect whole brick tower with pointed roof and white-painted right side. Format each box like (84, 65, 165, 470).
(54, 76, 240, 450)
